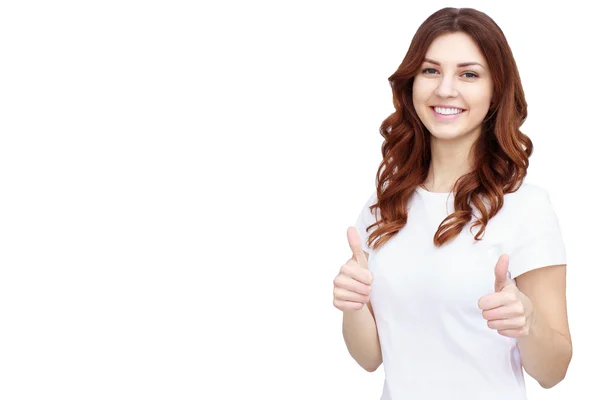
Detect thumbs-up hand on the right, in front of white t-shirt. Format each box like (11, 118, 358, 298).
(477, 254, 534, 338)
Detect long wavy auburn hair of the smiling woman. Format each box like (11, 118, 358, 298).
(367, 7, 533, 249)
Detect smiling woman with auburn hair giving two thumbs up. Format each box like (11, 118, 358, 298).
(334, 8, 572, 400)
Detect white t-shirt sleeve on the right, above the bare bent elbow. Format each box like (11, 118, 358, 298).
(508, 187, 567, 279)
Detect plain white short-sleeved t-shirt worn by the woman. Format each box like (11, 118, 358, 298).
(355, 183, 566, 400)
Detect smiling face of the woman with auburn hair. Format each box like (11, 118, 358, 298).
(412, 32, 493, 142)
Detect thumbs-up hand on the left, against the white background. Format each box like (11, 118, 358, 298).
(333, 226, 373, 311)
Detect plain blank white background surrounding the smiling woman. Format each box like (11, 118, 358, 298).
(0, 0, 600, 400)
